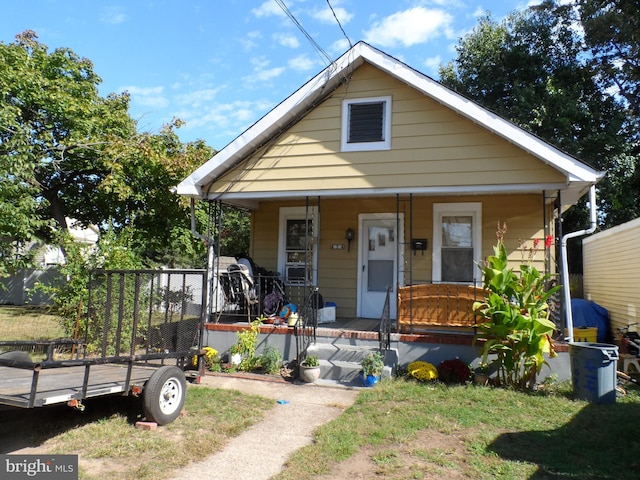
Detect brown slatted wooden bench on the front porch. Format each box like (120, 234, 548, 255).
(398, 283, 484, 332)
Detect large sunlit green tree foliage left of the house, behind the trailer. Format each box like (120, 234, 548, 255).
(0, 31, 214, 275)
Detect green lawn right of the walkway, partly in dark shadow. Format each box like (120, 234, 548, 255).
(276, 380, 640, 480)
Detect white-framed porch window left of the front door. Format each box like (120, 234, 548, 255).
(278, 207, 317, 285)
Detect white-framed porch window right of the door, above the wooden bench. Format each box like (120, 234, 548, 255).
(432, 203, 482, 283)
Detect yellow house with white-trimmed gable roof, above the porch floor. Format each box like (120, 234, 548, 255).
(177, 42, 602, 330)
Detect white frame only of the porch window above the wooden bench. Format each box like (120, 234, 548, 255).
(431, 202, 482, 283)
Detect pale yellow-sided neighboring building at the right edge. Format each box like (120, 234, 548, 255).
(582, 218, 640, 336)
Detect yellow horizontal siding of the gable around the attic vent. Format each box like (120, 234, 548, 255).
(208, 64, 565, 193)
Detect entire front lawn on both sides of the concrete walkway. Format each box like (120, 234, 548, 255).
(5, 370, 640, 480)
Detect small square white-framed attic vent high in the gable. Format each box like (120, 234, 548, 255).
(342, 97, 391, 152)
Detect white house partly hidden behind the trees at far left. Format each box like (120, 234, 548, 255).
(0, 218, 99, 305)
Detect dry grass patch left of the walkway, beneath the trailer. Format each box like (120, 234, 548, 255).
(0, 385, 275, 480)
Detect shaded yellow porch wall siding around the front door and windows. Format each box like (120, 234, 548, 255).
(250, 195, 544, 318)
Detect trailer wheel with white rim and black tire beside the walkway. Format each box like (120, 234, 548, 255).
(142, 366, 187, 425)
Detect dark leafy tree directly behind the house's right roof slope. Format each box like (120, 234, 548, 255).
(440, 1, 640, 230)
